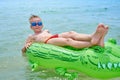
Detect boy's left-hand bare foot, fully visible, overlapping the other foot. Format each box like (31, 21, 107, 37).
(91, 24, 105, 45)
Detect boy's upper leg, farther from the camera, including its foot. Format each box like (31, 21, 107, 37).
(59, 24, 104, 43)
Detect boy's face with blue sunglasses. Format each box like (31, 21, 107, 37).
(30, 18, 43, 33)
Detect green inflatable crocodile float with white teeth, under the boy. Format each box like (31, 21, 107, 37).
(26, 39, 120, 79)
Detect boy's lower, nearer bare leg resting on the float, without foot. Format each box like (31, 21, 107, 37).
(47, 38, 92, 48)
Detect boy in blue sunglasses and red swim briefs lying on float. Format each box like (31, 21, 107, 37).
(22, 15, 108, 53)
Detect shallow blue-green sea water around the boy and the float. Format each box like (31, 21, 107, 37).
(0, 0, 120, 80)
